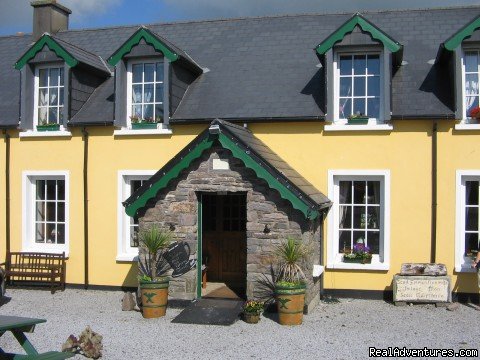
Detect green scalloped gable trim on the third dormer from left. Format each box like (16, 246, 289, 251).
(315, 14, 403, 55)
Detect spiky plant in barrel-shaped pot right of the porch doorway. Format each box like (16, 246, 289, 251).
(275, 237, 308, 325)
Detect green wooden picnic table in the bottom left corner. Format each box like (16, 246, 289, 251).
(0, 315, 75, 360)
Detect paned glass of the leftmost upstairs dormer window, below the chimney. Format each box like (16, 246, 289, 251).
(37, 67, 65, 125)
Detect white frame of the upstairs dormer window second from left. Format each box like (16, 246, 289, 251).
(126, 57, 169, 131)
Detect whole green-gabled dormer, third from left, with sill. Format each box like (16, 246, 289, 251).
(315, 13, 403, 130)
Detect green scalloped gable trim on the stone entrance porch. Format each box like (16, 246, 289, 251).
(124, 121, 331, 220)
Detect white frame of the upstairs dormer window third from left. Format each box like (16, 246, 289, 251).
(333, 49, 385, 125)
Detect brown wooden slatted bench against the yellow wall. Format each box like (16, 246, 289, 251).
(3, 252, 66, 294)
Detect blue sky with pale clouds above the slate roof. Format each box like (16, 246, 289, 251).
(0, 0, 478, 35)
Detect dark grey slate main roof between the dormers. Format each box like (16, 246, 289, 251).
(0, 6, 480, 126)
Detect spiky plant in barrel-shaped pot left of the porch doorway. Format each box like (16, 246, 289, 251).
(139, 225, 172, 318)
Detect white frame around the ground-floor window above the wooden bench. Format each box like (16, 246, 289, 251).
(22, 171, 70, 256)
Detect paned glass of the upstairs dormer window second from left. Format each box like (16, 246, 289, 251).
(131, 61, 164, 122)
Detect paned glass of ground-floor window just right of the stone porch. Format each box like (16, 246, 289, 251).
(338, 181, 382, 254)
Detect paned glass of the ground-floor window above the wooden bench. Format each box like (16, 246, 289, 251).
(34, 179, 65, 244)
